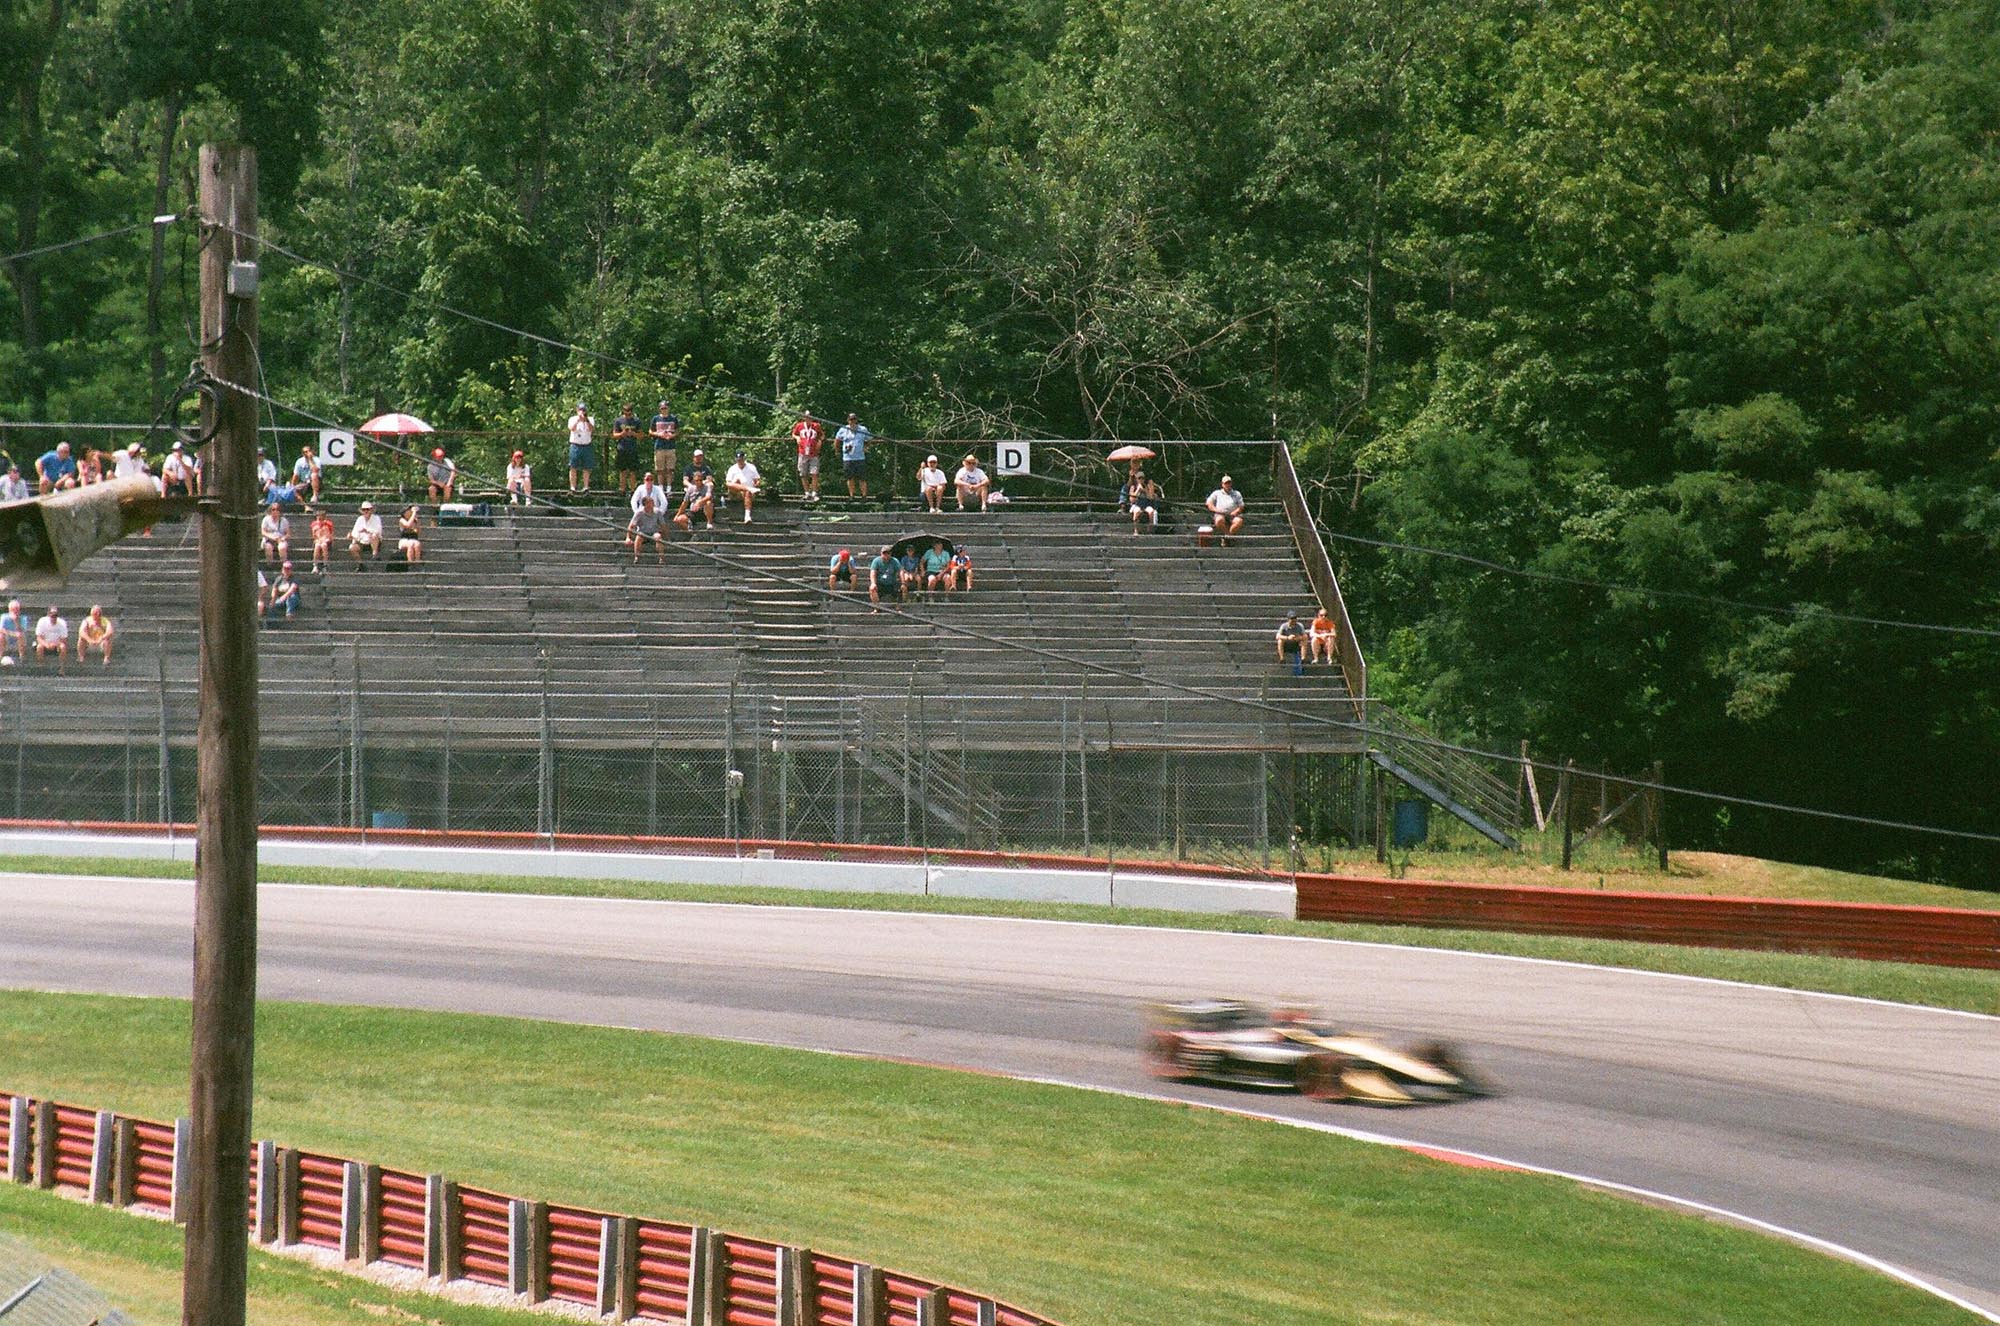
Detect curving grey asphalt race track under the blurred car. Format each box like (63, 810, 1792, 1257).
(0, 876, 2000, 1320)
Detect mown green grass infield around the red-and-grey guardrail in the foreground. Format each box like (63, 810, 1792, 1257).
(0, 994, 1968, 1326)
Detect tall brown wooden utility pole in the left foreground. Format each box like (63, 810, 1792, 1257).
(180, 144, 258, 1326)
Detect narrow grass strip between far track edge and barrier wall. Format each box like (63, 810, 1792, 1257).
(0, 856, 2000, 1016)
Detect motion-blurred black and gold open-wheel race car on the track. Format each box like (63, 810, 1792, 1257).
(1146, 1000, 1492, 1104)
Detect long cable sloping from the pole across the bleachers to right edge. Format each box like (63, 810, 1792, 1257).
(208, 376, 2000, 844)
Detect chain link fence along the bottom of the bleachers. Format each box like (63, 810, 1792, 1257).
(0, 668, 1372, 874)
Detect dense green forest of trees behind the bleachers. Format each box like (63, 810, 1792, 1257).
(0, 0, 2000, 884)
